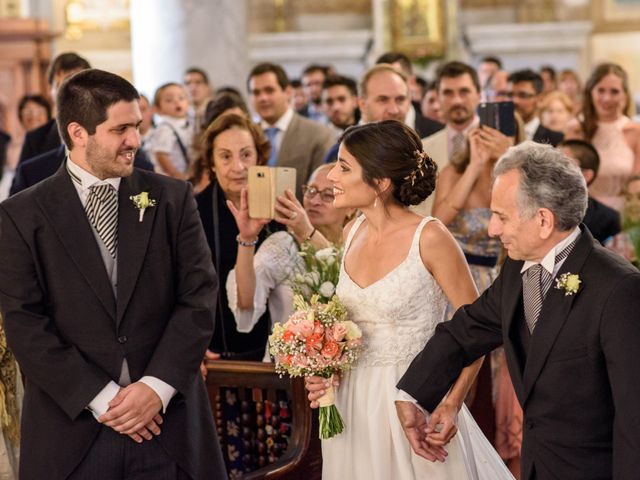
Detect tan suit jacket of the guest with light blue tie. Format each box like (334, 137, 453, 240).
(276, 113, 335, 200)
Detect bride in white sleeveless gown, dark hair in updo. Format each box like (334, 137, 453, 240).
(307, 120, 513, 480)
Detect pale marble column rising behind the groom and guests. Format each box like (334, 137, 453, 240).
(131, 0, 248, 95)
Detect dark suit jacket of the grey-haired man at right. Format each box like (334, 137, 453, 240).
(398, 226, 640, 480)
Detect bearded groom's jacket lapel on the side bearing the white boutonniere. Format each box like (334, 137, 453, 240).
(116, 170, 162, 324)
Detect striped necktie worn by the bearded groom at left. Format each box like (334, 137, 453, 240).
(84, 183, 118, 259)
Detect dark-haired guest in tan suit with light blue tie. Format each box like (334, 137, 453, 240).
(247, 63, 334, 199)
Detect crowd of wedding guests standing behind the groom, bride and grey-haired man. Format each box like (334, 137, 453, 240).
(0, 52, 640, 475)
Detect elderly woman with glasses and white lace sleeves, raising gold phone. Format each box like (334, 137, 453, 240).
(226, 164, 352, 360)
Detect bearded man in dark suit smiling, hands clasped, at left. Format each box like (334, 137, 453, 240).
(0, 70, 226, 480)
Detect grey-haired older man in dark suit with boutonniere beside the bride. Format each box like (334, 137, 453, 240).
(397, 142, 640, 480)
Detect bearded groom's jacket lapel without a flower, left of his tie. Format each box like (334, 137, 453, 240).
(37, 162, 116, 319)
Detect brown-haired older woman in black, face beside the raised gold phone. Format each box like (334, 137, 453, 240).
(196, 114, 283, 361)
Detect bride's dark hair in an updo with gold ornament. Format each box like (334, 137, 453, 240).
(340, 120, 438, 206)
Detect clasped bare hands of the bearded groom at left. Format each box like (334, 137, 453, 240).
(98, 382, 162, 443)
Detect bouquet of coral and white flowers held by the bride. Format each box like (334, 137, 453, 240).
(269, 295, 362, 439)
